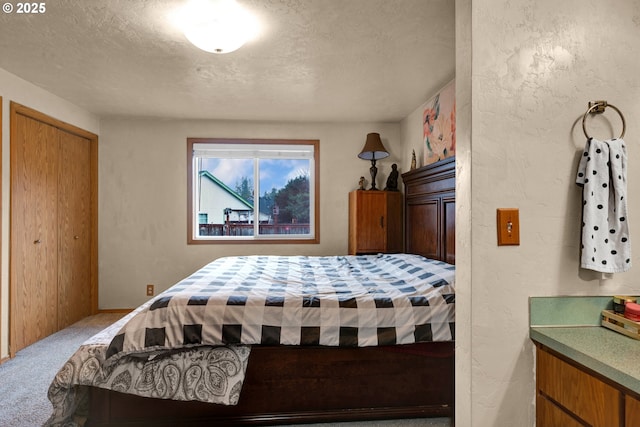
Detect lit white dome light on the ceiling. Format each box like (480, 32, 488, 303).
(182, 0, 257, 53)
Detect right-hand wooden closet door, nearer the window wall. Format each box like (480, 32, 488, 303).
(58, 130, 91, 329)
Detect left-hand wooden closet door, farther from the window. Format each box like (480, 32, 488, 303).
(10, 114, 60, 352)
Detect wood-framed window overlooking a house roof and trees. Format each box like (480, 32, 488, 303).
(187, 138, 320, 244)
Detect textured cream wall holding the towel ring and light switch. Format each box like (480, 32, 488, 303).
(456, 0, 640, 427)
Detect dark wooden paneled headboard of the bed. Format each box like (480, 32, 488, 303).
(402, 157, 456, 264)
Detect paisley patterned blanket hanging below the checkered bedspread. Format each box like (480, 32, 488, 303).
(45, 304, 250, 427)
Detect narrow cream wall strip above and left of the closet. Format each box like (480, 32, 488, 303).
(0, 68, 100, 359)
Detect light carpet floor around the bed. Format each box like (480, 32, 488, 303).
(0, 313, 451, 427)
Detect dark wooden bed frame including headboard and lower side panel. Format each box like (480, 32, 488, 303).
(88, 158, 455, 426)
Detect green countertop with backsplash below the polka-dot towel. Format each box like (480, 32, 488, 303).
(529, 297, 640, 394)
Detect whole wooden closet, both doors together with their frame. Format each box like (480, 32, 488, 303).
(9, 103, 97, 356)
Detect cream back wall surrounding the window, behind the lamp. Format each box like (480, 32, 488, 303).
(99, 118, 402, 309)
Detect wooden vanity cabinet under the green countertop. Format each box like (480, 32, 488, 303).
(536, 344, 640, 427)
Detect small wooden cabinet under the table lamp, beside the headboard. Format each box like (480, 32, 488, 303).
(349, 190, 402, 255)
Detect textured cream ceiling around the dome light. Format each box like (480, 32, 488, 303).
(0, 0, 455, 121)
